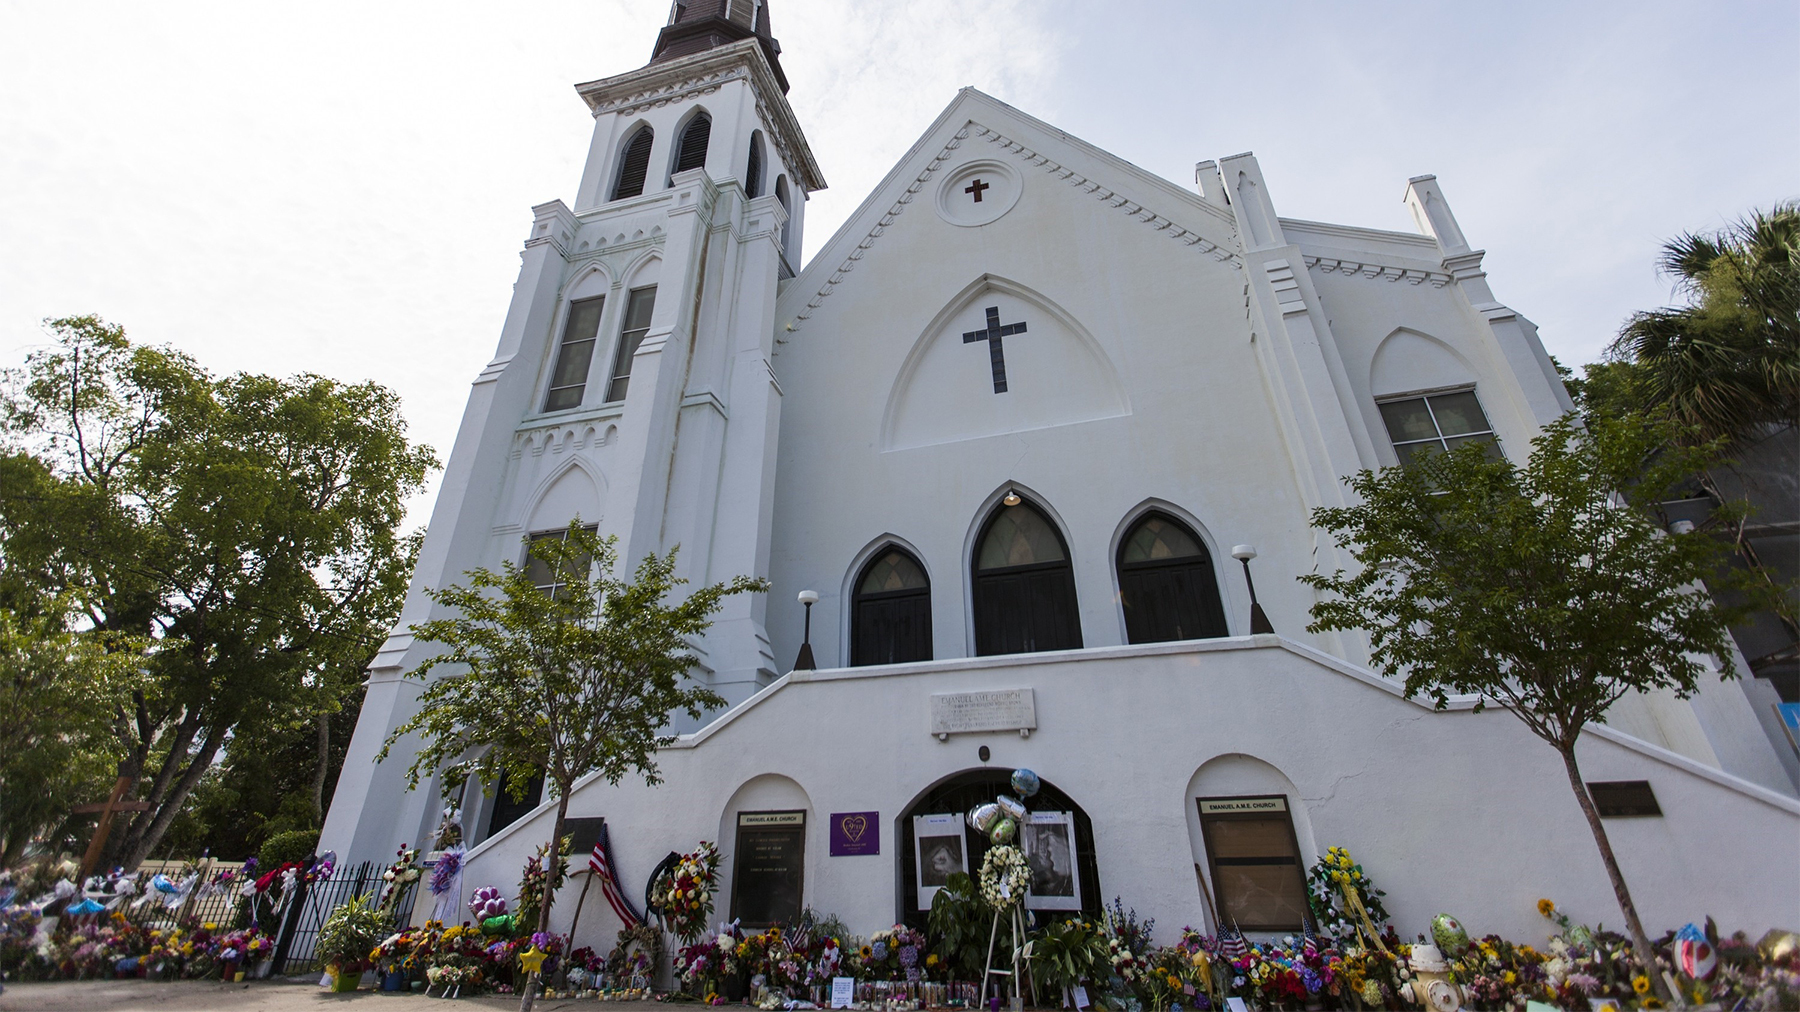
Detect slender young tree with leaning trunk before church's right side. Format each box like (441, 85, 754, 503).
(1301, 416, 1764, 1001)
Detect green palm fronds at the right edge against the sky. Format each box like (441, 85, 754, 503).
(1613, 203, 1800, 443)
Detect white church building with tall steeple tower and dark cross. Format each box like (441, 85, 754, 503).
(320, 0, 1800, 951)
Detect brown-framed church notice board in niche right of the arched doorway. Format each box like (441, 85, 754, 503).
(1195, 796, 1307, 931)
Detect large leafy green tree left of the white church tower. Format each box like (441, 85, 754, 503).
(0, 317, 436, 866)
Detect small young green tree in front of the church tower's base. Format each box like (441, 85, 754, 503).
(380, 517, 769, 1012)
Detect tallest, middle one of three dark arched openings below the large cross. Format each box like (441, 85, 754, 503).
(974, 502, 1082, 655)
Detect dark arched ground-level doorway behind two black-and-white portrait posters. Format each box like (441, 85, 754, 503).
(895, 767, 1102, 931)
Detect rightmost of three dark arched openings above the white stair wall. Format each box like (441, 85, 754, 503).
(1120, 513, 1228, 643)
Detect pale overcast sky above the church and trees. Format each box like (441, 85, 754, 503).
(0, 0, 1800, 507)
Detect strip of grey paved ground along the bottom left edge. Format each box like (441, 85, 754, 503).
(0, 980, 668, 1012)
